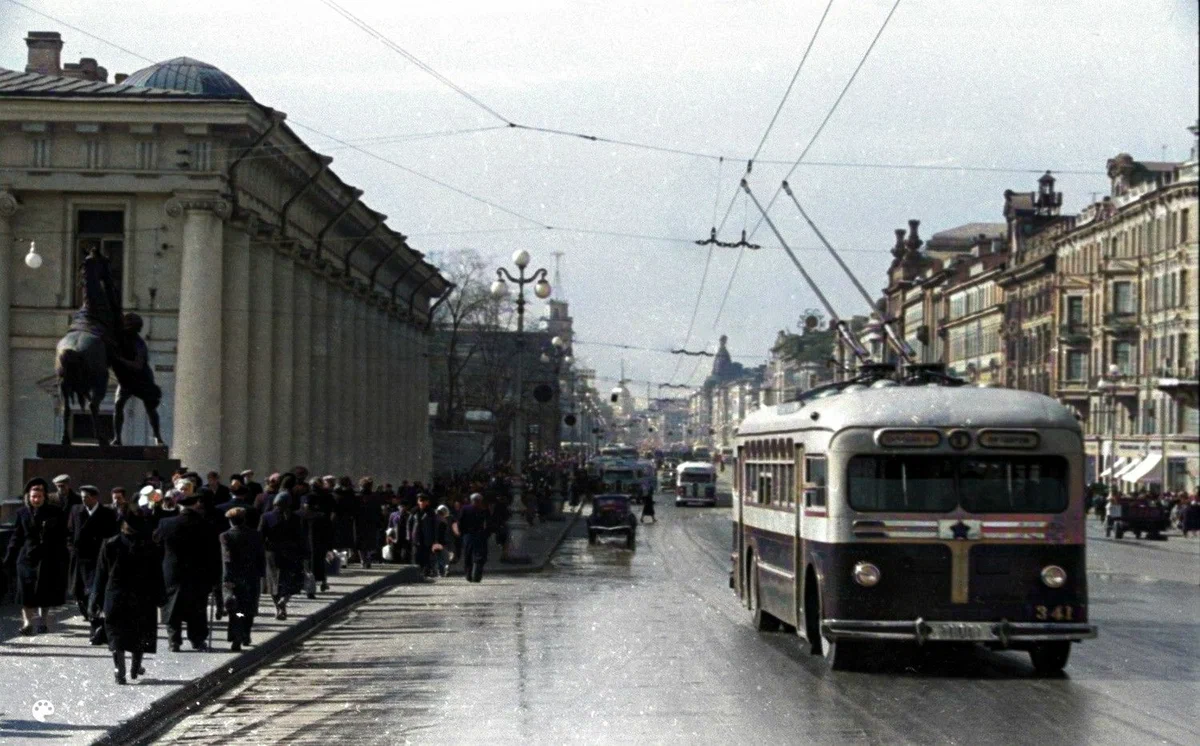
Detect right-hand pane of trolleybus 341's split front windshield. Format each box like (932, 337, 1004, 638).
(959, 456, 1067, 513)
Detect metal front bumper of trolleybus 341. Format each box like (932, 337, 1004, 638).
(821, 619, 1097, 648)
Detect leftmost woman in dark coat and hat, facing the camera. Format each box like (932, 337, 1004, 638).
(4, 477, 67, 634)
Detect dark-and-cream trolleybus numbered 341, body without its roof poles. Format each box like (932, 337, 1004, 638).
(732, 379, 1096, 673)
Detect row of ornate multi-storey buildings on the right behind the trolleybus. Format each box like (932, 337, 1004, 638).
(839, 133, 1200, 491)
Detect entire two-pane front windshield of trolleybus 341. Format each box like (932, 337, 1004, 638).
(848, 455, 1067, 513)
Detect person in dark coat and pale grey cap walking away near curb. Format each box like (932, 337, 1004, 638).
(221, 506, 266, 652)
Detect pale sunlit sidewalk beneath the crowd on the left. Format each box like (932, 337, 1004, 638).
(0, 506, 582, 745)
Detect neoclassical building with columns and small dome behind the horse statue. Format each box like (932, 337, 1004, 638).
(0, 32, 450, 494)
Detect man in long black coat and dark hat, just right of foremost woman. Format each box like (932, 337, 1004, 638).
(155, 494, 221, 652)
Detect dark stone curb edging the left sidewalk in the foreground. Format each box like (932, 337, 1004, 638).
(92, 566, 425, 746)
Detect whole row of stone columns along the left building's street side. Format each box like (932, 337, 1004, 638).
(167, 197, 432, 483)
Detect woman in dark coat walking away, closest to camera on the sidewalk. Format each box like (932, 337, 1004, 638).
(90, 512, 167, 684)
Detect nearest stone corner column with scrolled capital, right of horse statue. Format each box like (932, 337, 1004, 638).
(167, 195, 229, 474)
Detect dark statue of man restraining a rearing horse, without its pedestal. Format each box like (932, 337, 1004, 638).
(54, 247, 166, 445)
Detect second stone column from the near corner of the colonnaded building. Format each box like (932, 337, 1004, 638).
(222, 223, 253, 474)
